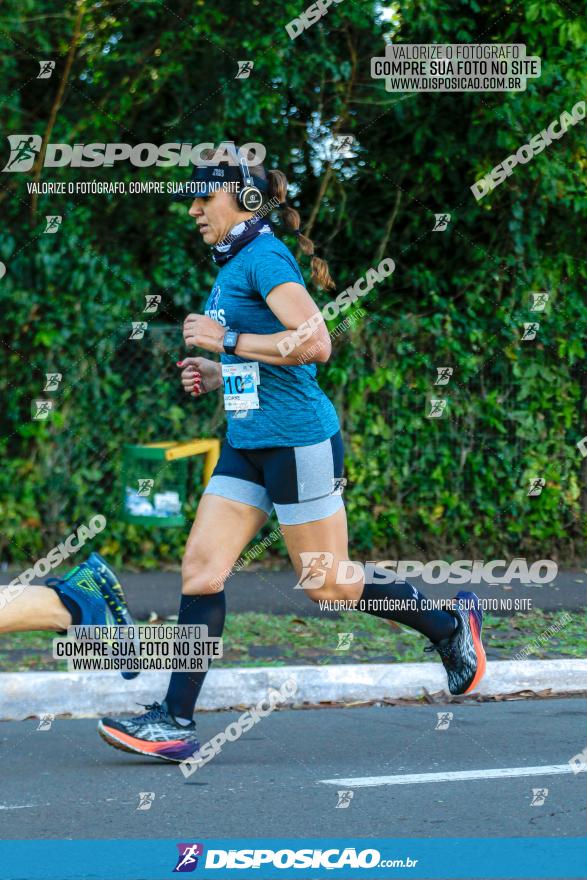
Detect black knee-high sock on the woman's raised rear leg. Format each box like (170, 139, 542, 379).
(357, 568, 457, 642)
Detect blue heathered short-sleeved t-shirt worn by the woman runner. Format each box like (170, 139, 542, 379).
(205, 234, 339, 449)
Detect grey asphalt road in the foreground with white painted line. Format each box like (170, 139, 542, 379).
(0, 699, 587, 840)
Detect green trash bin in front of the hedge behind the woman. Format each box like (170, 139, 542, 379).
(122, 443, 187, 528)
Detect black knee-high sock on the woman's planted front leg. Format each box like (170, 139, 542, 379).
(165, 590, 226, 718)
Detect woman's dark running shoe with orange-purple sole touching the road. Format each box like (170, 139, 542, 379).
(98, 702, 200, 764)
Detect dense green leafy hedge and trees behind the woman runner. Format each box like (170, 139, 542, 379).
(0, 0, 587, 566)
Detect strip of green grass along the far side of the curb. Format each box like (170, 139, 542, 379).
(0, 609, 587, 672)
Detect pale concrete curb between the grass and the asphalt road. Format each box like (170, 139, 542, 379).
(0, 659, 587, 721)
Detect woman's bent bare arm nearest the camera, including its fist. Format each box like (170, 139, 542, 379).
(183, 281, 332, 366)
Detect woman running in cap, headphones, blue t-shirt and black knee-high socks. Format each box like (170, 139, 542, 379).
(99, 150, 485, 761)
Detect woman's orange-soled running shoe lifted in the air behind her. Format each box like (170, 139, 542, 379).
(424, 590, 486, 696)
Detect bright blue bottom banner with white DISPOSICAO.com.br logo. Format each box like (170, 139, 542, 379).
(0, 837, 587, 880)
